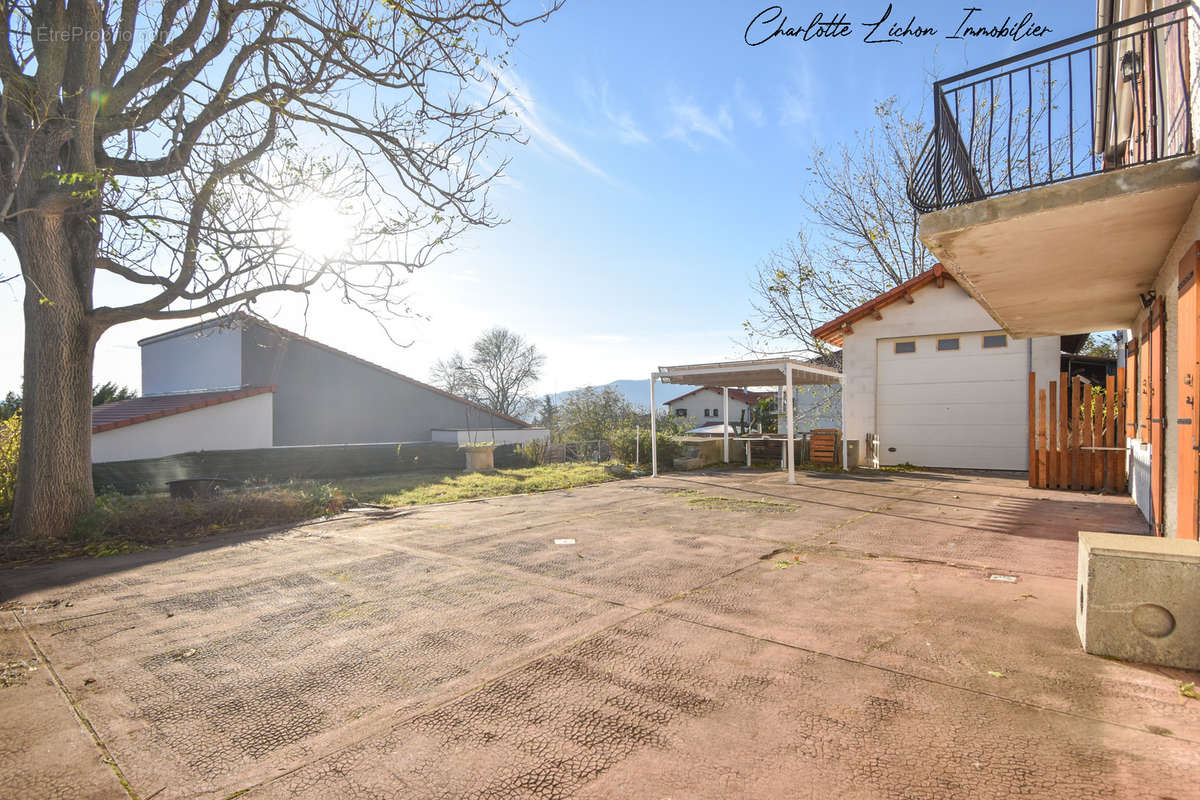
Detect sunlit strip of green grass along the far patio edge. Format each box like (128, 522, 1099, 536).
(336, 464, 629, 506)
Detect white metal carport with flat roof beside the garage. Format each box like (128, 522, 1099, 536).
(650, 359, 847, 483)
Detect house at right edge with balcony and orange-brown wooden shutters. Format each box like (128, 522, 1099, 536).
(907, 0, 1200, 539)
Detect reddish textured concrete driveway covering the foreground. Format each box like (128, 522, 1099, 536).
(0, 471, 1200, 800)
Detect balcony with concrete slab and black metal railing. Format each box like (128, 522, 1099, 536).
(908, 2, 1200, 336)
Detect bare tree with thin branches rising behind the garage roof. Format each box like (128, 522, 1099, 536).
(744, 98, 934, 355)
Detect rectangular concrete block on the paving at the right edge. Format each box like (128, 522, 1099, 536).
(1075, 531, 1200, 669)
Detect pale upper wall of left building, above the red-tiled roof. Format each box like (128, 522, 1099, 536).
(142, 327, 241, 395)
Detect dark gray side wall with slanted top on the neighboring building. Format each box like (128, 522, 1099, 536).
(241, 323, 522, 447)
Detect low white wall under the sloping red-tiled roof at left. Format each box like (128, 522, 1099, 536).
(91, 392, 272, 463)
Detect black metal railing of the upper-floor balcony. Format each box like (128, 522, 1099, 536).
(908, 1, 1195, 213)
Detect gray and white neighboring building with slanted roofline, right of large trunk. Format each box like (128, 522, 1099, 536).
(92, 314, 546, 462)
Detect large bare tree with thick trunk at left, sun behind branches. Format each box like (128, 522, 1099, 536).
(0, 0, 558, 536)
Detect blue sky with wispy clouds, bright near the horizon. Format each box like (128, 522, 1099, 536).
(0, 0, 1094, 393)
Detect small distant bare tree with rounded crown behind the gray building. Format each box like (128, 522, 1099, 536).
(433, 327, 546, 416)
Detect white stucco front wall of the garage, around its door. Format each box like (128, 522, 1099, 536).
(842, 281, 1060, 470)
